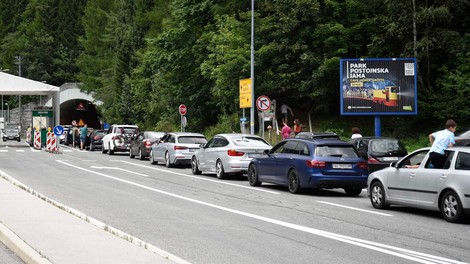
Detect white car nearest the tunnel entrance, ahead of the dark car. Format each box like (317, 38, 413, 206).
(101, 125, 139, 155)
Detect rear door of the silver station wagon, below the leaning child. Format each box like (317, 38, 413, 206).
(416, 151, 455, 206)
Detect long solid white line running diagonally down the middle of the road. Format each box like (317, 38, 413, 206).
(57, 160, 465, 264)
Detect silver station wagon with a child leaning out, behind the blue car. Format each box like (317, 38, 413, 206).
(367, 147, 470, 222)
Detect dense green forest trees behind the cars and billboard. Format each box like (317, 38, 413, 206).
(0, 0, 470, 137)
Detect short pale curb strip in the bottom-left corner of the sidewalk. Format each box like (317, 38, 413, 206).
(0, 223, 52, 264)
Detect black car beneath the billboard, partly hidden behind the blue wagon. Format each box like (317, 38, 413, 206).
(349, 137, 408, 173)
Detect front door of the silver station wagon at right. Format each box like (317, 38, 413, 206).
(386, 150, 428, 203)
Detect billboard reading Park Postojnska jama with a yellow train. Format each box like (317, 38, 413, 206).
(340, 58, 418, 115)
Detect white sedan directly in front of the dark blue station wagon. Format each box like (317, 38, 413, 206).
(191, 134, 271, 179)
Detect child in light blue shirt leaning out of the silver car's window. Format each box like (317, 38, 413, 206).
(429, 119, 457, 168)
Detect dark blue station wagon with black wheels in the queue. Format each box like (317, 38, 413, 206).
(248, 138, 369, 196)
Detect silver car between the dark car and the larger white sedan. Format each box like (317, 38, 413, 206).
(149, 132, 207, 167)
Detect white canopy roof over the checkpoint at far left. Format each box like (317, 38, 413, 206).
(0, 72, 60, 95)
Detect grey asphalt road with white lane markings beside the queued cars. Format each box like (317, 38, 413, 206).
(0, 142, 470, 264)
